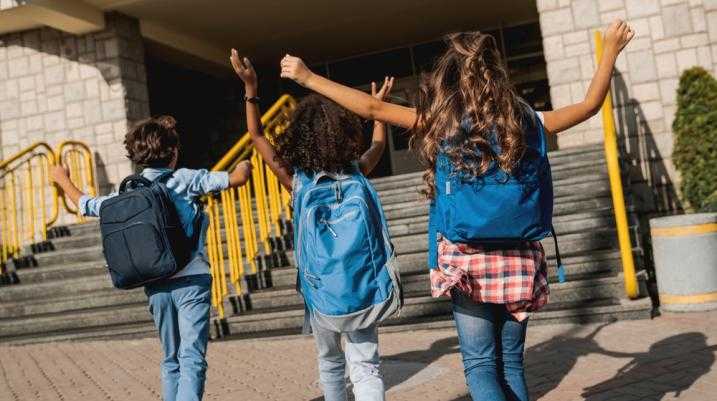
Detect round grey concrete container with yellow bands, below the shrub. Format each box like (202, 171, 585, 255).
(650, 213, 717, 312)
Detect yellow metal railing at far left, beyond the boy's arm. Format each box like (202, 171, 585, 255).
(0, 141, 96, 282)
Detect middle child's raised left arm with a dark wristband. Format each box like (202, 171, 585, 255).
(230, 49, 293, 190)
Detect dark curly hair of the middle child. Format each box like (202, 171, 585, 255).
(275, 94, 363, 172)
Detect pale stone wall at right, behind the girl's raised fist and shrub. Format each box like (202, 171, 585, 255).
(537, 0, 717, 212)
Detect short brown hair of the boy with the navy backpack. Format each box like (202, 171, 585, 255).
(124, 116, 179, 167)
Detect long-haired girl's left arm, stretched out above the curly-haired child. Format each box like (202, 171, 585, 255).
(281, 54, 416, 128)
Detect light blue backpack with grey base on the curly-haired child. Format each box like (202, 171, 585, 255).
(293, 165, 403, 332)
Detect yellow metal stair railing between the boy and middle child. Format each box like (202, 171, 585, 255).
(206, 95, 296, 319)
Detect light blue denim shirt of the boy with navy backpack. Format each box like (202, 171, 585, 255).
(79, 167, 229, 277)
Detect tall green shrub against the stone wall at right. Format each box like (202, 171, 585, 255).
(672, 67, 717, 210)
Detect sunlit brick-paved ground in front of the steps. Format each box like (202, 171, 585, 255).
(0, 312, 717, 401)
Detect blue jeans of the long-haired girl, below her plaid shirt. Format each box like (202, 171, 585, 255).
(452, 290, 528, 401)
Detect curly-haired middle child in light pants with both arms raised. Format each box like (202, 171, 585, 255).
(231, 50, 403, 401)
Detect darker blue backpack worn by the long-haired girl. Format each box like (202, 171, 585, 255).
(428, 110, 565, 282)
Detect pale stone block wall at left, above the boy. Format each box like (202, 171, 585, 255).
(0, 14, 149, 193)
